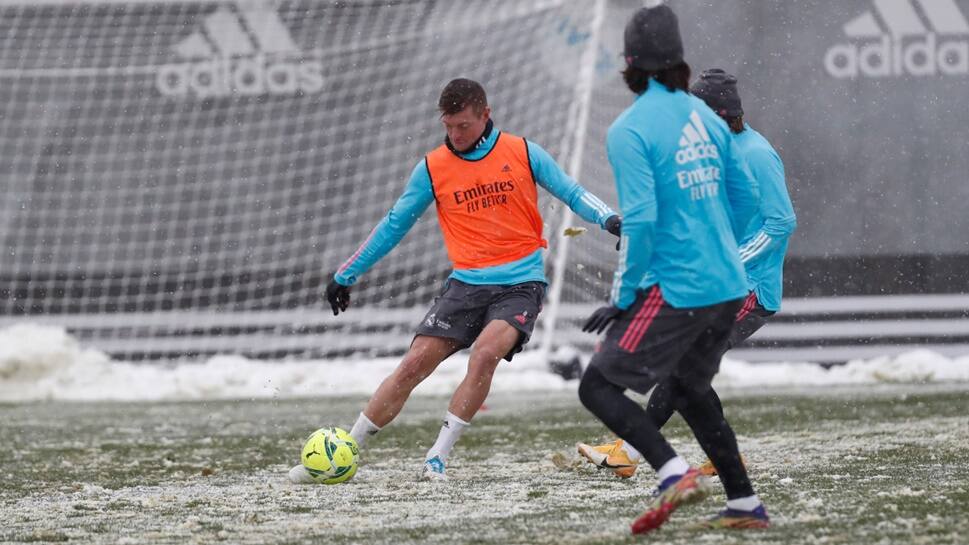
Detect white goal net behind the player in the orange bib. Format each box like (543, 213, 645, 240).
(0, 0, 641, 359)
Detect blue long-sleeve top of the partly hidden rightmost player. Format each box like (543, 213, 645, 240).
(734, 124, 797, 312)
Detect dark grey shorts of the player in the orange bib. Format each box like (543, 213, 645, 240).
(417, 278, 545, 361)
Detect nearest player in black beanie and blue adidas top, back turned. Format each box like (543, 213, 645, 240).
(579, 5, 768, 534)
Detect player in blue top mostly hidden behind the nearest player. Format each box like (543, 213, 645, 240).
(578, 68, 797, 484)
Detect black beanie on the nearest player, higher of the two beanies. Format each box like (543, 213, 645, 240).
(623, 5, 683, 72)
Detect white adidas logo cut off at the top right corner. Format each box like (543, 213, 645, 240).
(824, 0, 969, 78)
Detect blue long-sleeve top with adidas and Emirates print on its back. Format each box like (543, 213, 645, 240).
(606, 80, 760, 309)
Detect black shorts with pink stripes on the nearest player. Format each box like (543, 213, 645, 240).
(590, 286, 743, 395)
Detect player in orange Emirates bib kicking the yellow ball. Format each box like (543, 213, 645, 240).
(289, 79, 621, 482)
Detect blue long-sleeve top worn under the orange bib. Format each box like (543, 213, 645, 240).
(334, 126, 616, 286)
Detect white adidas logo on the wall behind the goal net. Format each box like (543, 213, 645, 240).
(155, 2, 323, 98)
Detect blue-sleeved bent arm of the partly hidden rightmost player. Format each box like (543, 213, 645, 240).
(740, 149, 797, 266)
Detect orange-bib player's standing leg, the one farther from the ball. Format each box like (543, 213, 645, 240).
(421, 320, 521, 479)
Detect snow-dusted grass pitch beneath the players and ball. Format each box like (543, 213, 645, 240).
(0, 386, 969, 545)
